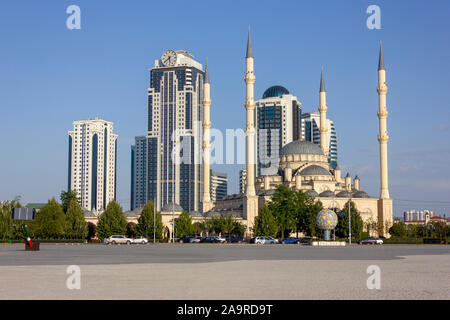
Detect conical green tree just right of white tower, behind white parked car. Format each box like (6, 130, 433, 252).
(97, 200, 127, 240)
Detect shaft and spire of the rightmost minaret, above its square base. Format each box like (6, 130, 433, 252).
(377, 41, 389, 199)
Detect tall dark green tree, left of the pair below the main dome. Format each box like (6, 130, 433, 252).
(269, 185, 297, 238)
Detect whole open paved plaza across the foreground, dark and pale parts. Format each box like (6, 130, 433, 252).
(0, 244, 450, 299)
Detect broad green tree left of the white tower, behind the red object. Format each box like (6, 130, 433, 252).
(33, 198, 66, 239)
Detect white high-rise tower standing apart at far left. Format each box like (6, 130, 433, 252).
(67, 118, 117, 211)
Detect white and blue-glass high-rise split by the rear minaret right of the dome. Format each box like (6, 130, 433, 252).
(301, 112, 338, 169)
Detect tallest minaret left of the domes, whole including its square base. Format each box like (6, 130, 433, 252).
(243, 28, 258, 236)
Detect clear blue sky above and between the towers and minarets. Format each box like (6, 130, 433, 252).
(0, 0, 450, 216)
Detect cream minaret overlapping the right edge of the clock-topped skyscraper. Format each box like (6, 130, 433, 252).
(202, 59, 212, 212)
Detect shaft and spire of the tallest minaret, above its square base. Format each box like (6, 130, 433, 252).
(245, 28, 256, 196)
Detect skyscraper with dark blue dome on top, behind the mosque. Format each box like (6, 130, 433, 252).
(256, 86, 302, 176)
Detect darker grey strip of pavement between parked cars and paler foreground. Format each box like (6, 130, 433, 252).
(0, 244, 450, 266)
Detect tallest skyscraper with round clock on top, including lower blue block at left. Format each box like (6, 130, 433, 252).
(131, 50, 204, 211)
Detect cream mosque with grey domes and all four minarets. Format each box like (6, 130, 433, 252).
(192, 32, 393, 237)
